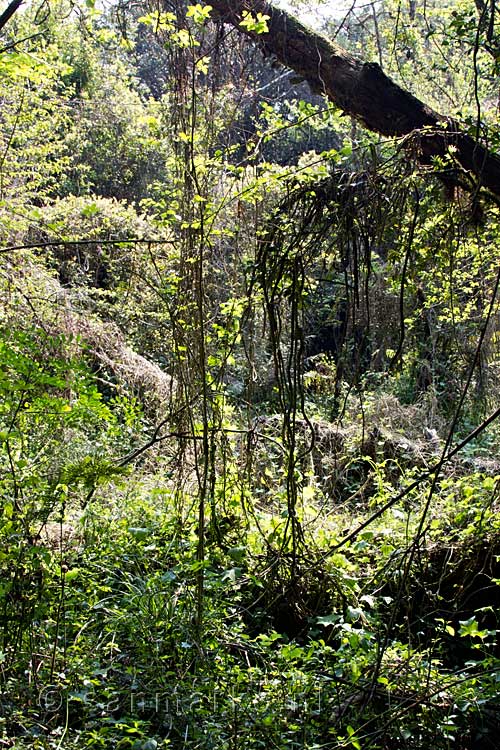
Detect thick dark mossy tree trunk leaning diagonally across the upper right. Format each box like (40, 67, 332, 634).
(210, 0, 500, 198)
